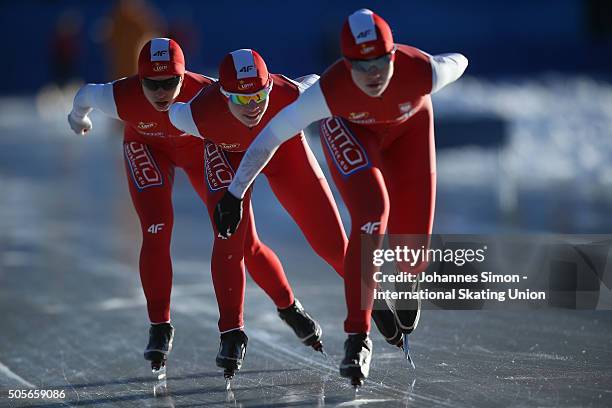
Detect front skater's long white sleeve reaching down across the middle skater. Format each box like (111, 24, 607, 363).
(228, 78, 332, 198)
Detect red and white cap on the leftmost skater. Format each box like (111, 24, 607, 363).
(138, 38, 185, 78)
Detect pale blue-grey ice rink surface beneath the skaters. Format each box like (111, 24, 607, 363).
(0, 78, 612, 407)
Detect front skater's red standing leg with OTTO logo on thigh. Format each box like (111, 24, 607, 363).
(321, 118, 389, 333)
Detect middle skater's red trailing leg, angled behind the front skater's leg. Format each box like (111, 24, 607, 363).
(264, 136, 347, 276)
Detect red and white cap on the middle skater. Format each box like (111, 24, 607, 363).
(219, 48, 270, 94)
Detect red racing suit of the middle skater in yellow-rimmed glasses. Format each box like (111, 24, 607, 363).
(170, 74, 347, 330)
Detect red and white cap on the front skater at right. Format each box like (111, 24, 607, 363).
(340, 9, 394, 60)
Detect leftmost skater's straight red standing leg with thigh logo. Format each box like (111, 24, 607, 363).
(123, 141, 174, 323)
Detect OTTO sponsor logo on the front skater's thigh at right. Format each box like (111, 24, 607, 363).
(321, 118, 369, 176)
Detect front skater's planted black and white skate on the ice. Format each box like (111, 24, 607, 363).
(340, 333, 372, 389)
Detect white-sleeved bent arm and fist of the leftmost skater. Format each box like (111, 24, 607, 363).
(68, 82, 119, 135)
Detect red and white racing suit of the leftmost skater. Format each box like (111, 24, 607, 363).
(75, 72, 322, 325)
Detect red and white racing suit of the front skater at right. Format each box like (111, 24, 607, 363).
(228, 44, 467, 333)
